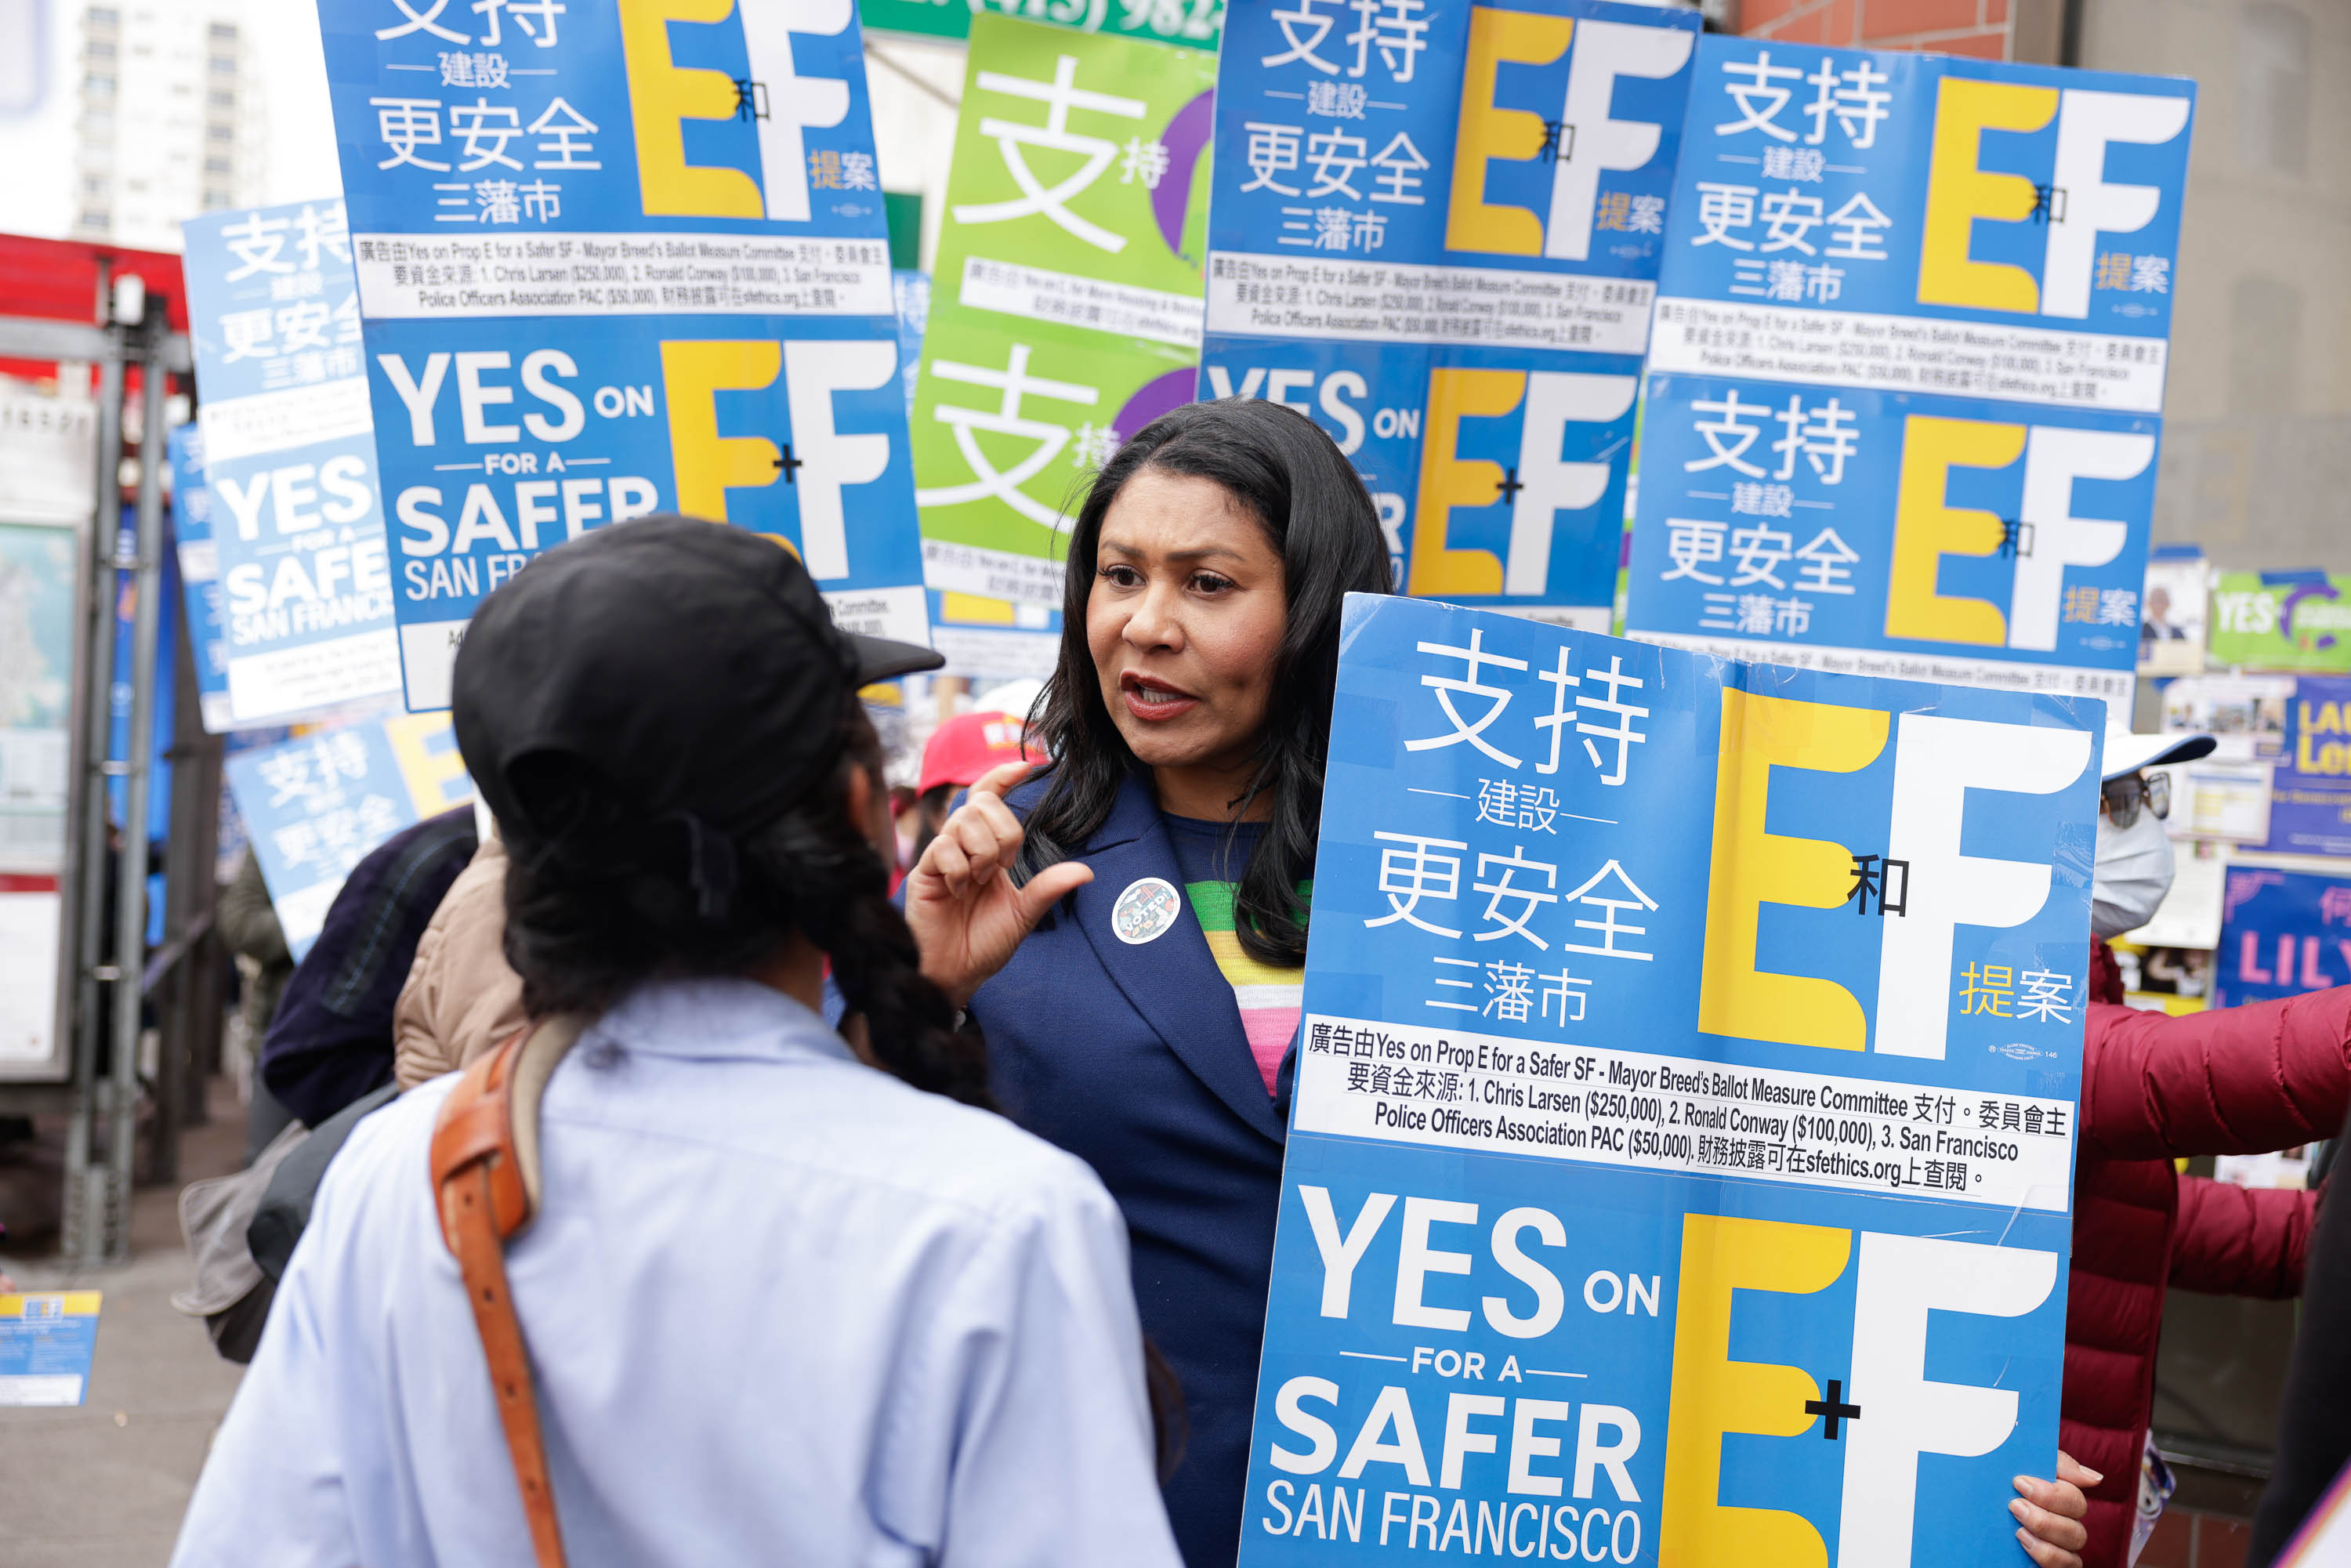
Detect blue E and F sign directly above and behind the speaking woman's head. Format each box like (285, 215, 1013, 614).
(1201, 0, 1697, 625)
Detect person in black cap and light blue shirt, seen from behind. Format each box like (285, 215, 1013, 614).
(174, 517, 1176, 1568)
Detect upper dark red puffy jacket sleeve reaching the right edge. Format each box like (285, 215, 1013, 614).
(2081, 985, 2351, 1159)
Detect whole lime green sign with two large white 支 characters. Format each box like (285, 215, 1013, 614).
(915, 14, 1215, 675)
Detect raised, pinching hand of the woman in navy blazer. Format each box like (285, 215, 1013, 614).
(905, 762, 1093, 1006)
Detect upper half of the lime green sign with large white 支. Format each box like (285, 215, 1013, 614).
(936, 14, 1215, 355)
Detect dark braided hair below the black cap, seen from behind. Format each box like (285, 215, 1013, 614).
(501, 703, 992, 1105)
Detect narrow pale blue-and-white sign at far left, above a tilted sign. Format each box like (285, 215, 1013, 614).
(181, 202, 400, 724)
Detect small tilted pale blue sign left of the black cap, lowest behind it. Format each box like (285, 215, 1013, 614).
(228, 712, 473, 961)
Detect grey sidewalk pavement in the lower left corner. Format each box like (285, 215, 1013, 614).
(0, 1079, 245, 1568)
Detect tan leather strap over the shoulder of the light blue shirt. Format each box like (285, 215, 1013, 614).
(433, 1018, 581, 1568)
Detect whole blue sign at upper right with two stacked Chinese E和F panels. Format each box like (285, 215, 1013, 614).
(1625, 38, 2193, 698)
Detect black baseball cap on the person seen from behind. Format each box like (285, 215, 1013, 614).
(451, 512, 945, 837)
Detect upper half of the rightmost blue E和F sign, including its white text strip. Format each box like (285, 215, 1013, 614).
(1653, 38, 2196, 414)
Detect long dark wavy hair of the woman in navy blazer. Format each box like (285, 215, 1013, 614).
(1025, 397, 1394, 966)
